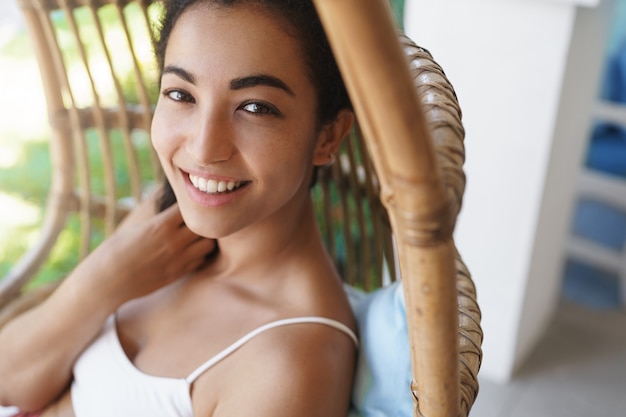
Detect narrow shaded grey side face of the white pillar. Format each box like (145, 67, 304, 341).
(515, 1, 610, 367)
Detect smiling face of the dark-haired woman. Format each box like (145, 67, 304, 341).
(152, 3, 328, 238)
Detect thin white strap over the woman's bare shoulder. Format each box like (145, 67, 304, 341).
(185, 316, 359, 384)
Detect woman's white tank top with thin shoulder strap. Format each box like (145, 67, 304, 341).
(72, 316, 358, 417)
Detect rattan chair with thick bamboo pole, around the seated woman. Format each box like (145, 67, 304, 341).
(0, 0, 482, 417)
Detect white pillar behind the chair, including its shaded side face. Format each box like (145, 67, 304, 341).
(405, 0, 599, 381)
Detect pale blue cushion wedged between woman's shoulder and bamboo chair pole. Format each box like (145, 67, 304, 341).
(346, 282, 413, 417)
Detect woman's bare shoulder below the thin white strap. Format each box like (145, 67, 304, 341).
(214, 323, 357, 417)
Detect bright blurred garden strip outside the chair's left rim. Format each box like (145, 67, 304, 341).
(0, 1, 50, 286)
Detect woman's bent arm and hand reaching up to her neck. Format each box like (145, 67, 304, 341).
(0, 194, 215, 411)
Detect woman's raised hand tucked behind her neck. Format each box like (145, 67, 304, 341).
(79, 204, 216, 307)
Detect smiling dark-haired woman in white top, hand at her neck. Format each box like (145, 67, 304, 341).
(0, 0, 356, 417)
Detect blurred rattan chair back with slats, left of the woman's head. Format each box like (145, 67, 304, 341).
(0, 0, 161, 305)
